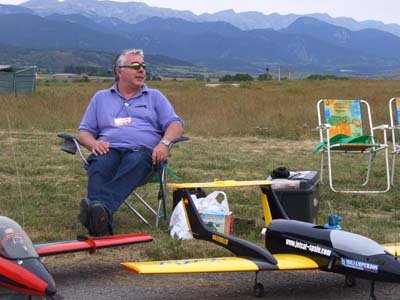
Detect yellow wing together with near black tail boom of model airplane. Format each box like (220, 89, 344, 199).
(121, 186, 319, 274)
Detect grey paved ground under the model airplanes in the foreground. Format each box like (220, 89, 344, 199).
(0, 254, 400, 300)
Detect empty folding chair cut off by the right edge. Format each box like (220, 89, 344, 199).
(389, 97, 400, 185)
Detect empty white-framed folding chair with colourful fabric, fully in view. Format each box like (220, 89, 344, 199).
(314, 99, 390, 193)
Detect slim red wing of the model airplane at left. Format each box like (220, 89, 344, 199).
(34, 233, 153, 256)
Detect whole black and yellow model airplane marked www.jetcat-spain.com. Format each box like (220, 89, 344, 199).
(122, 181, 400, 299)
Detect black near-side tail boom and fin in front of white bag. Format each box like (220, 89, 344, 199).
(182, 190, 277, 267)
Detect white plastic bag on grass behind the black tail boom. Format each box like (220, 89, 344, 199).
(169, 191, 230, 240)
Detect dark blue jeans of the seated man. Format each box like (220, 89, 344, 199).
(87, 148, 153, 228)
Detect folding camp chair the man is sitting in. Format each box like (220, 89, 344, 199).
(57, 133, 189, 227)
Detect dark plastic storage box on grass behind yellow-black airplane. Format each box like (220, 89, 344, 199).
(267, 171, 321, 224)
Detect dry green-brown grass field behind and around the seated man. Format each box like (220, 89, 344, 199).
(0, 80, 400, 259)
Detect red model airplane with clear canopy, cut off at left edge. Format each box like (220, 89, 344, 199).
(0, 216, 153, 296)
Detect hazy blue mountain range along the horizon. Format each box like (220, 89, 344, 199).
(0, 0, 400, 75)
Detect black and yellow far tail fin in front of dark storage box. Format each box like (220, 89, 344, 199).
(261, 185, 289, 226)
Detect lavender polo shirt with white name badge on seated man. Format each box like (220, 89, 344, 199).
(79, 84, 183, 149)
